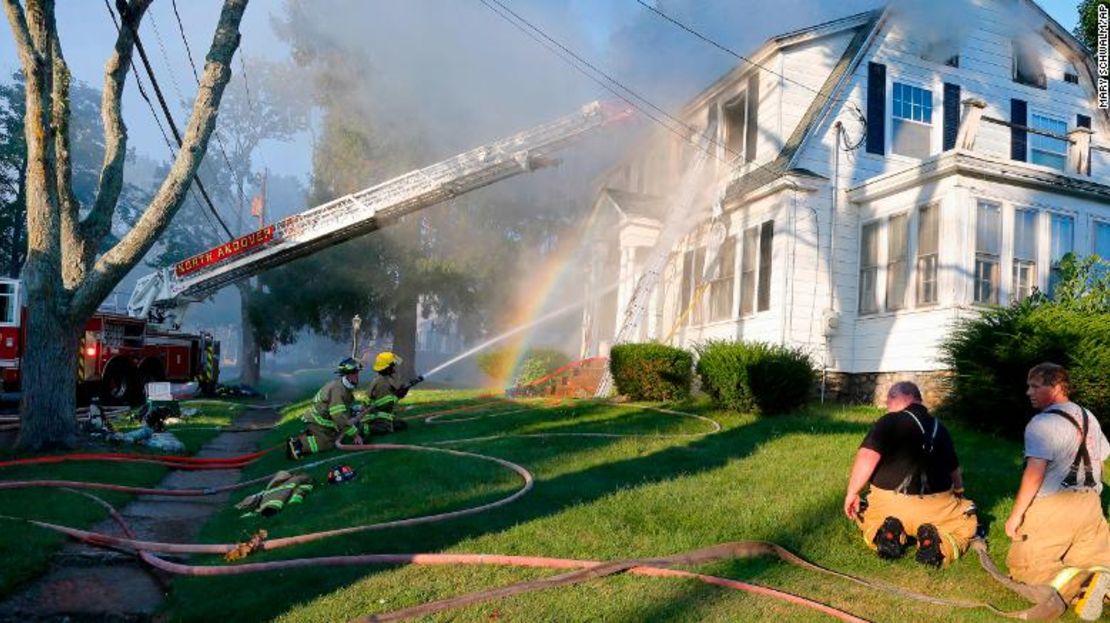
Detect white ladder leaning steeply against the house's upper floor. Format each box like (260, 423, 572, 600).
(595, 123, 724, 398)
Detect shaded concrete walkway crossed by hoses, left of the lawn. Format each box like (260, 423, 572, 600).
(0, 409, 278, 623)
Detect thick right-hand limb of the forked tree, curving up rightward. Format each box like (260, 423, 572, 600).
(71, 0, 248, 318)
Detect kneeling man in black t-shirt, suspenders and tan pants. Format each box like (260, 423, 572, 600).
(844, 381, 977, 566)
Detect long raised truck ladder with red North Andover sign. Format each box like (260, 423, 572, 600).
(128, 102, 632, 326)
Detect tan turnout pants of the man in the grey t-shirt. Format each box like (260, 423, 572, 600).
(1006, 491, 1110, 601)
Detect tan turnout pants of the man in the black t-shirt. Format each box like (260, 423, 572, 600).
(857, 486, 978, 565)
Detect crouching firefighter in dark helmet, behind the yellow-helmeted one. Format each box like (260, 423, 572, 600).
(286, 356, 362, 459)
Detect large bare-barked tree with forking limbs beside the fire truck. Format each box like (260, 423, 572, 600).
(3, 0, 248, 450)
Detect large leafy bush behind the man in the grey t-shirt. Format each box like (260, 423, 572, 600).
(942, 297, 1110, 439)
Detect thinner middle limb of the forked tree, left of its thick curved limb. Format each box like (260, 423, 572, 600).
(81, 0, 151, 255)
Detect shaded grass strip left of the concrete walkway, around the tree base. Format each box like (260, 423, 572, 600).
(0, 402, 241, 597)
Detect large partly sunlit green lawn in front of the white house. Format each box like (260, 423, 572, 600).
(154, 391, 1073, 622)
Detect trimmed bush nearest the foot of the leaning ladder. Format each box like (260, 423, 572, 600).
(609, 344, 694, 400)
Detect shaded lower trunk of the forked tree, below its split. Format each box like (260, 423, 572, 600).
(16, 297, 83, 451)
